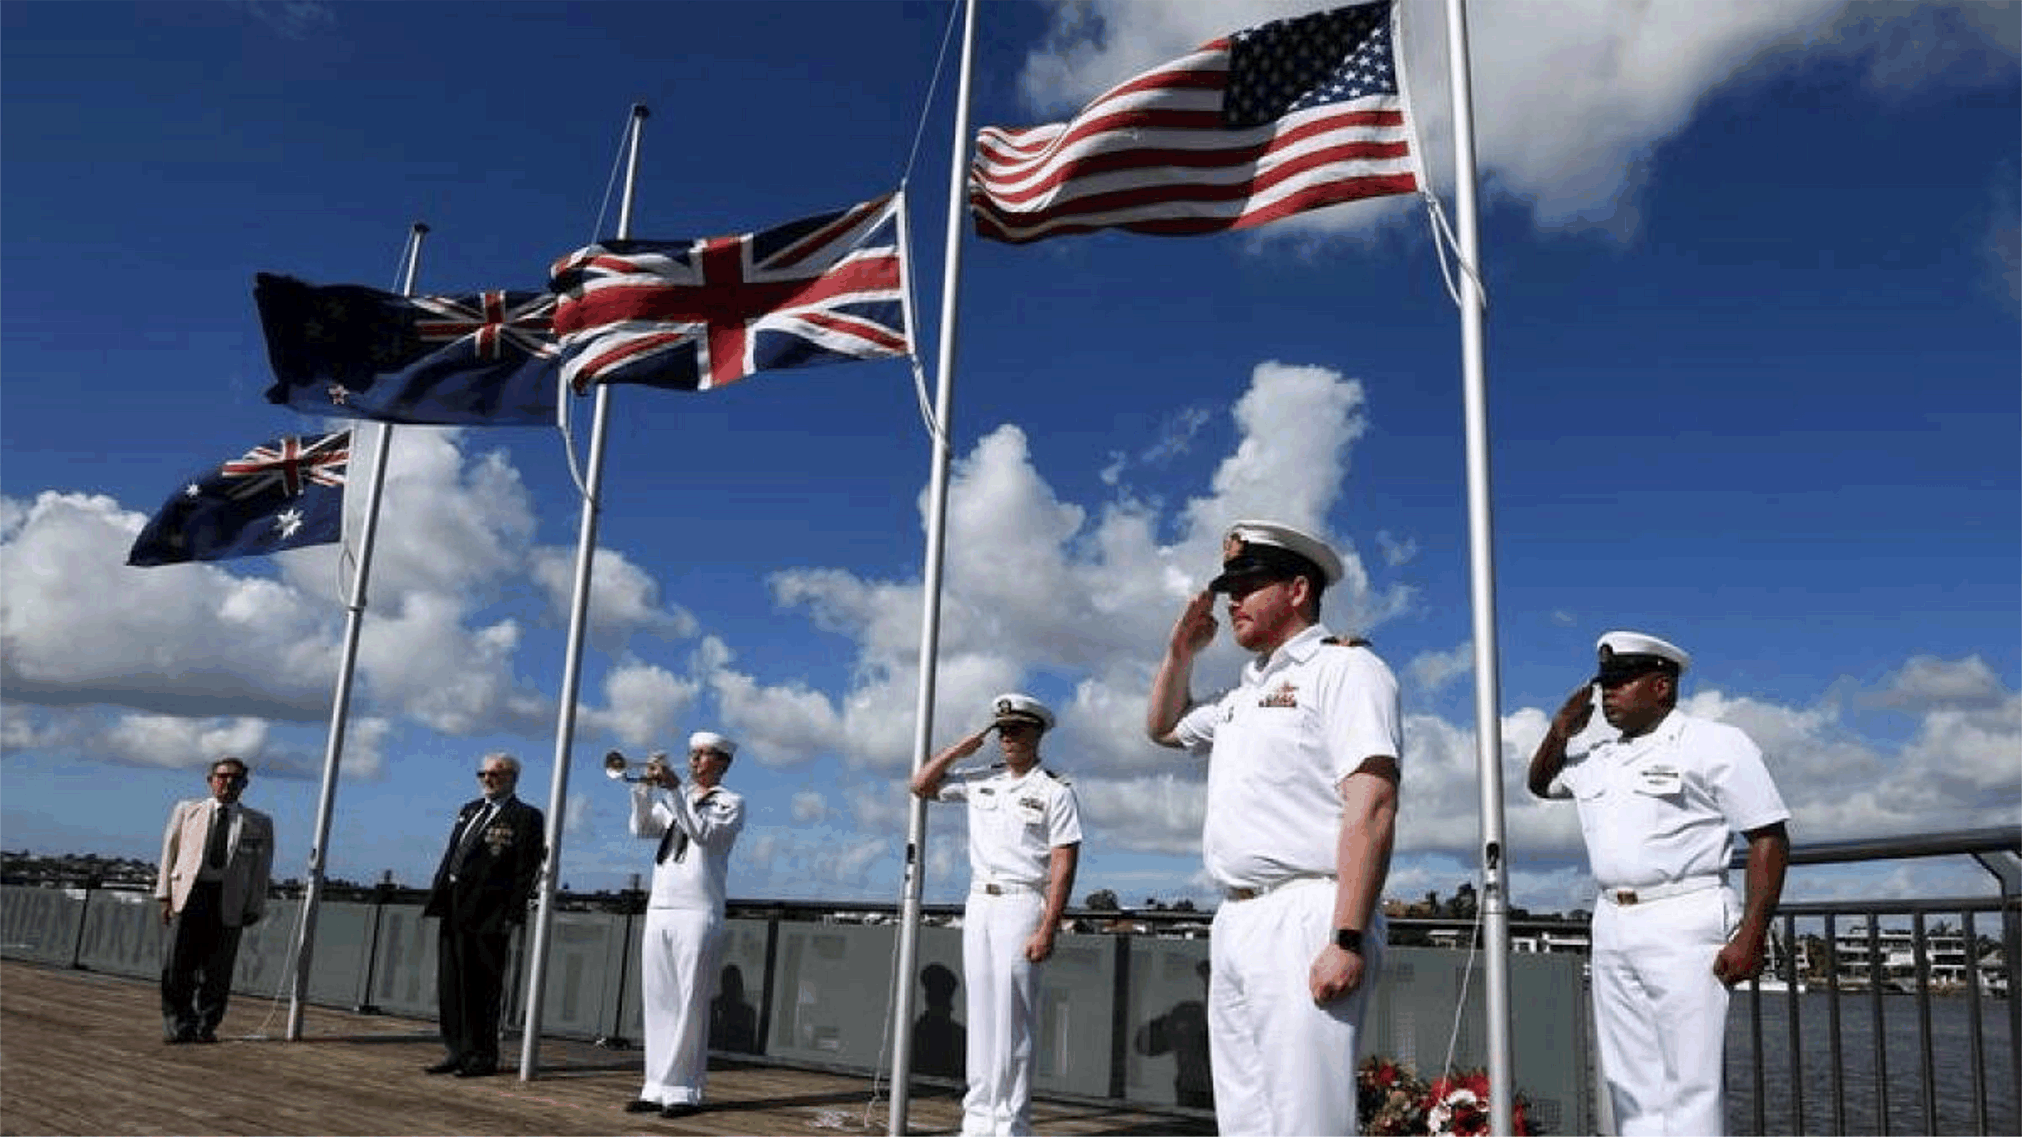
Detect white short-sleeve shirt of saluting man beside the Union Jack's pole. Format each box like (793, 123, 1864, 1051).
(934, 765, 1082, 888)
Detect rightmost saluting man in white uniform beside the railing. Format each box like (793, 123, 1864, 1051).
(1529, 631, 1789, 1137)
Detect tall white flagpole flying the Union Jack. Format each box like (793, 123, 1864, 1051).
(888, 0, 977, 1137)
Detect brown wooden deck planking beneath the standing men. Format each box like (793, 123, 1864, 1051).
(0, 961, 1215, 1135)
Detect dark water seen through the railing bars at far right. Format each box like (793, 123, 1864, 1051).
(1727, 987, 2022, 1133)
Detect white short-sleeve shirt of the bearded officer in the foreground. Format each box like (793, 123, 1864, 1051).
(1173, 625, 1403, 888)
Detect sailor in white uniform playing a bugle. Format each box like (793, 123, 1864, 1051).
(625, 730, 744, 1117)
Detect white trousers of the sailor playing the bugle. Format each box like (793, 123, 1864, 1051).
(639, 908, 724, 1105)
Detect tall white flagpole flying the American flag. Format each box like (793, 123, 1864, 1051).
(1446, 0, 1514, 1135)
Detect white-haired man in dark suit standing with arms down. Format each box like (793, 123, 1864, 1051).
(423, 753, 548, 1078)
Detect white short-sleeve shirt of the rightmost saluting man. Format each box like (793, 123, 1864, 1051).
(1549, 710, 1789, 888)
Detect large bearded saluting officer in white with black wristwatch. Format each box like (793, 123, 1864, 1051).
(1144, 522, 1403, 1133)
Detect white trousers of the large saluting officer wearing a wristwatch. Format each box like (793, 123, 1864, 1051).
(1207, 878, 1387, 1137)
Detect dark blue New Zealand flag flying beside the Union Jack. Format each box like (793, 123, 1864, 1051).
(253, 273, 560, 427)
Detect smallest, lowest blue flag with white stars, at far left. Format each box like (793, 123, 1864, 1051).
(127, 431, 352, 569)
